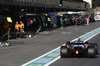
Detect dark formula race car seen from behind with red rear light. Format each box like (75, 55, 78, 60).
(60, 41, 98, 58)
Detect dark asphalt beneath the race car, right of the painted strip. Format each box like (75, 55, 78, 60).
(49, 34, 100, 66)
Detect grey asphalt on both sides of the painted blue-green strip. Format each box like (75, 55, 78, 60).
(0, 22, 100, 66)
